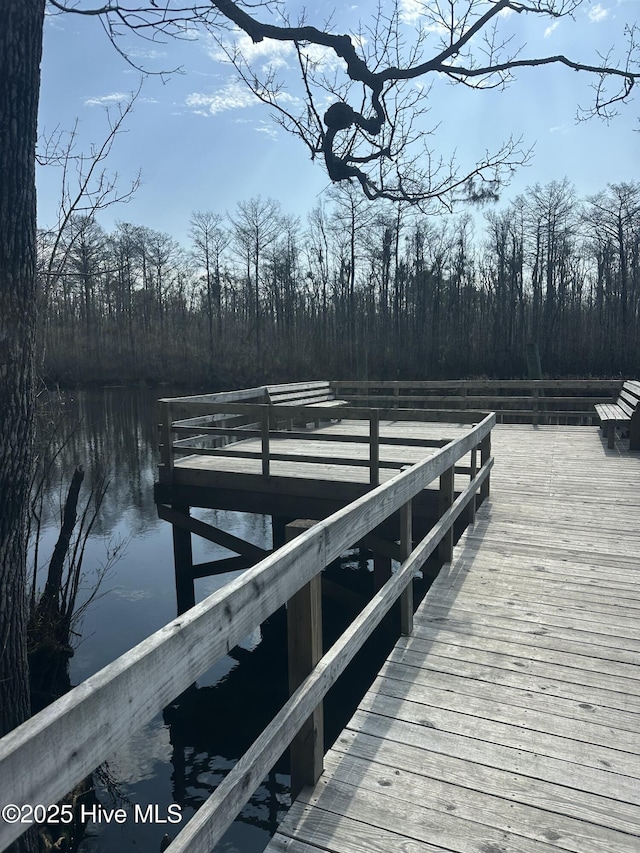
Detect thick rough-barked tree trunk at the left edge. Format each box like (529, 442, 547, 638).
(0, 0, 45, 735)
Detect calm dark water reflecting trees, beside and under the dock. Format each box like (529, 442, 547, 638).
(30, 389, 289, 853)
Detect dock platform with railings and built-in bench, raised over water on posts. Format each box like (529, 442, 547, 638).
(155, 382, 490, 611)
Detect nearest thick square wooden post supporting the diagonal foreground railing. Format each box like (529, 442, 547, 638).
(286, 521, 324, 801)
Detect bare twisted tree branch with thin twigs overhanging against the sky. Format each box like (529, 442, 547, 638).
(49, 0, 640, 205)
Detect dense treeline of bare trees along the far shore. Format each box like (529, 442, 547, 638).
(39, 179, 640, 390)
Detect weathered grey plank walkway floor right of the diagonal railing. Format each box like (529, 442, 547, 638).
(267, 426, 640, 853)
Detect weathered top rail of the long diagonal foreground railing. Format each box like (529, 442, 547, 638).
(0, 413, 496, 844)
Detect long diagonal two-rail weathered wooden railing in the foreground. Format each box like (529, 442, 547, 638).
(0, 414, 495, 853)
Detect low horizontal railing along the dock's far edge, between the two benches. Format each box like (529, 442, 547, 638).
(331, 379, 622, 424)
